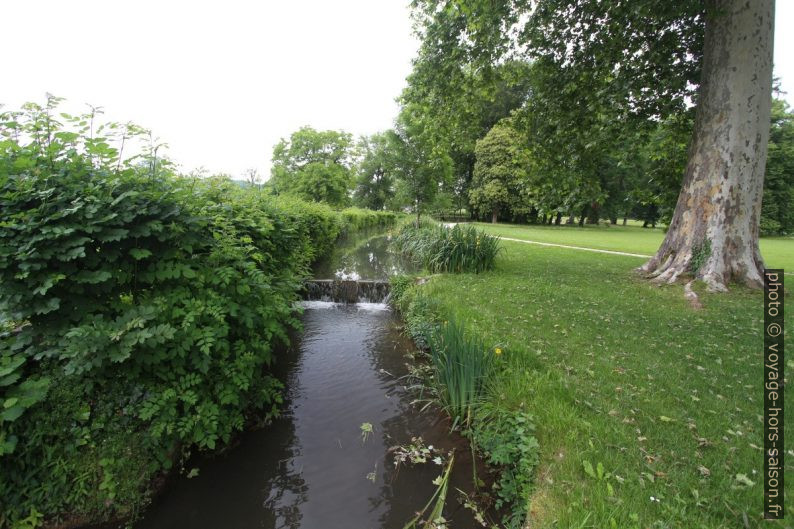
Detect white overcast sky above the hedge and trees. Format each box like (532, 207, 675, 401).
(0, 0, 794, 176)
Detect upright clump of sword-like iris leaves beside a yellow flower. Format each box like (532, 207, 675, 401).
(430, 321, 493, 428)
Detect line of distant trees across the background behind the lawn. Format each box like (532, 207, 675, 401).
(264, 93, 794, 235)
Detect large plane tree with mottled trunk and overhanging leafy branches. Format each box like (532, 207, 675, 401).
(406, 0, 774, 290)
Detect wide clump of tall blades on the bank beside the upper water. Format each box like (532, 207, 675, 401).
(395, 223, 501, 273)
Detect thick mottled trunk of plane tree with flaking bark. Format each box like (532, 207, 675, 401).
(640, 0, 775, 291)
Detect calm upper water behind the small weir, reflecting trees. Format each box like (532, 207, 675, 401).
(314, 234, 416, 281)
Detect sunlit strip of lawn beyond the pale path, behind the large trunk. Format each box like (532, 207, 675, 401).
(476, 222, 794, 273)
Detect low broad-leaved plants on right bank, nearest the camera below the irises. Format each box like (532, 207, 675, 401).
(472, 405, 540, 529)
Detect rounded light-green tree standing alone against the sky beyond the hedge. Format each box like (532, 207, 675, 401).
(268, 127, 353, 207)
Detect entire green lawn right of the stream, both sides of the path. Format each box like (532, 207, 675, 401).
(414, 225, 794, 529)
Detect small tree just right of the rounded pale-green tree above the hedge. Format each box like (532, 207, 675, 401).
(353, 132, 394, 210)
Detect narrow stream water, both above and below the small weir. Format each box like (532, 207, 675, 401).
(136, 233, 486, 529)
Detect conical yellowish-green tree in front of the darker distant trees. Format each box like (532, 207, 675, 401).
(469, 120, 529, 223)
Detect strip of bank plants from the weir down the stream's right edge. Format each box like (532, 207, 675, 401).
(391, 270, 539, 528)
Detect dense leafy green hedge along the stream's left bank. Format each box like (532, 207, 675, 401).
(0, 100, 394, 527)
